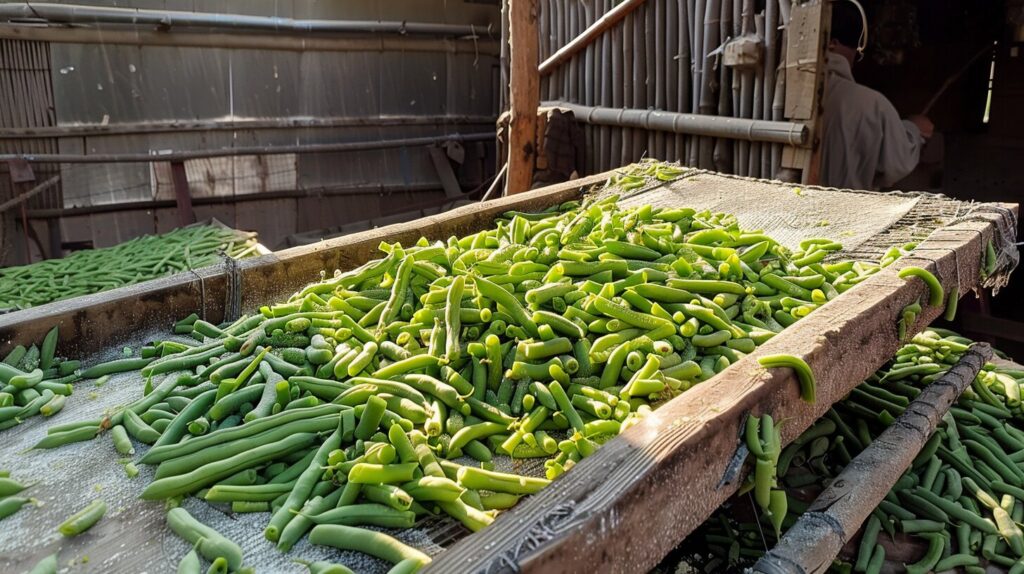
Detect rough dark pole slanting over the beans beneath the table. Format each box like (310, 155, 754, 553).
(750, 343, 992, 574)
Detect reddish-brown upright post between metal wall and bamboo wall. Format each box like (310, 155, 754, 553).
(507, 0, 541, 195)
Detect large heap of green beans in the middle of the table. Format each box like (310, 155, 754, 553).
(34, 192, 912, 572)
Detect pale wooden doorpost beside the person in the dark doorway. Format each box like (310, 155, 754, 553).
(782, 0, 831, 183)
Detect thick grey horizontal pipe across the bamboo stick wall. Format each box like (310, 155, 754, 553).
(540, 101, 808, 144)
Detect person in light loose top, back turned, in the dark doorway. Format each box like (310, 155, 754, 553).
(820, 0, 935, 189)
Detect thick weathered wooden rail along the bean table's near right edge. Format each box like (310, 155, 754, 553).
(428, 210, 1016, 573)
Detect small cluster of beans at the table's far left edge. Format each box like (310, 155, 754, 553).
(0, 326, 82, 431)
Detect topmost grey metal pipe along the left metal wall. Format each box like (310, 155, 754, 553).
(0, 2, 490, 36)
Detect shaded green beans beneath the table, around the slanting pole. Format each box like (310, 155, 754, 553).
(691, 329, 1024, 574)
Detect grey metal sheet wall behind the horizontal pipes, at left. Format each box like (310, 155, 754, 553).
(0, 0, 499, 252)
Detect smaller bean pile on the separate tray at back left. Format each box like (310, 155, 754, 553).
(0, 225, 257, 313)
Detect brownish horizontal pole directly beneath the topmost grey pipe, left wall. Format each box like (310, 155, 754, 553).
(0, 24, 499, 55)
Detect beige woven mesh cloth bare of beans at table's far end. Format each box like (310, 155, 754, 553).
(591, 163, 1020, 291)
